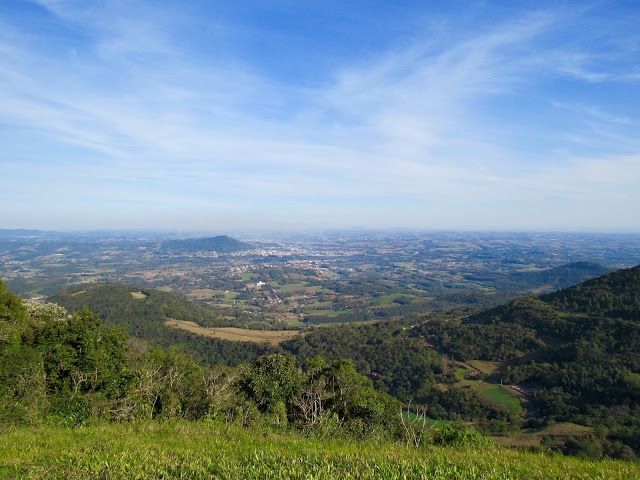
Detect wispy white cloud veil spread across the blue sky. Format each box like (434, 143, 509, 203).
(0, 0, 640, 231)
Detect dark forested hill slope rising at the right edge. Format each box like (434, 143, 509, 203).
(421, 266, 640, 458)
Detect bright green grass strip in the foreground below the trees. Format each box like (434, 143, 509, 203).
(0, 421, 640, 480)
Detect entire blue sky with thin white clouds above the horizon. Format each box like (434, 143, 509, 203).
(0, 0, 640, 232)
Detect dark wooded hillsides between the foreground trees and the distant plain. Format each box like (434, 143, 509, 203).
(22, 267, 640, 458)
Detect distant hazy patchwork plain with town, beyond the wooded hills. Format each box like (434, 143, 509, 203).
(0, 231, 640, 326)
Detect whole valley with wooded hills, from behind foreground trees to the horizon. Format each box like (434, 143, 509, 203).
(0, 232, 640, 464)
